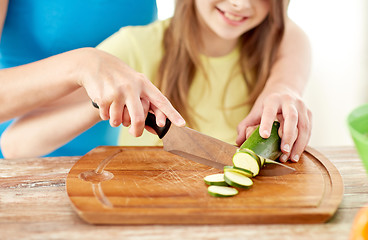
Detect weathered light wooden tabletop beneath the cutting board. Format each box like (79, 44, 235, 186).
(0, 146, 368, 240)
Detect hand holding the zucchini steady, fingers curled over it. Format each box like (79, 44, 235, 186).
(236, 89, 312, 162)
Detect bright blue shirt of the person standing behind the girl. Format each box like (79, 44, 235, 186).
(0, 0, 157, 157)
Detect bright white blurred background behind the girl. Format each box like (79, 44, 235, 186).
(157, 0, 368, 147)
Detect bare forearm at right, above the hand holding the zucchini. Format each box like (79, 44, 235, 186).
(264, 19, 311, 96)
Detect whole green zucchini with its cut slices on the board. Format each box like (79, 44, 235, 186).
(204, 122, 281, 197)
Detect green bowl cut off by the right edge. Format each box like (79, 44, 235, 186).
(348, 104, 368, 173)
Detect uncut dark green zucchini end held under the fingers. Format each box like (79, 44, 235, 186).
(240, 121, 282, 160)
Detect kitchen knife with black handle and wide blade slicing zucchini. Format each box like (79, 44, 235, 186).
(145, 113, 295, 176)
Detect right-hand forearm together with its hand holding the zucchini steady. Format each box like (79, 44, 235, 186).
(236, 19, 311, 161)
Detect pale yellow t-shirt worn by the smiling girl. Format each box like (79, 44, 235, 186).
(97, 20, 249, 146)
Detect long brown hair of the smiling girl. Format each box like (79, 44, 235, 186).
(157, 0, 288, 126)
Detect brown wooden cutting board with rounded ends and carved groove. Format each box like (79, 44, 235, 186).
(66, 147, 343, 224)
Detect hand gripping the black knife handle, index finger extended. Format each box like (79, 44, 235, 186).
(78, 48, 185, 137)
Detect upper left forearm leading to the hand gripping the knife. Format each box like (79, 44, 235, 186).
(0, 49, 89, 122)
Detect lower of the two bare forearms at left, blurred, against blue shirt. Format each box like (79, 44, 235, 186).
(1, 101, 100, 158)
